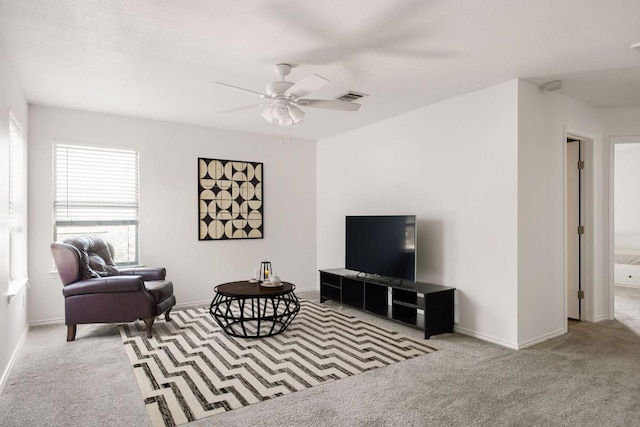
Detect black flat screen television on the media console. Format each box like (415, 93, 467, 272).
(345, 215, 417, 281)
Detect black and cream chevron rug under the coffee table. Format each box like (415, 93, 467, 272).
(120, 300, 436, 426)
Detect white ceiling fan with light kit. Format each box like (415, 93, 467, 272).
(215, 64, 360, 126)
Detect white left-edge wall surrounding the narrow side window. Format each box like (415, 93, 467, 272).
(0, 45, 28, 390)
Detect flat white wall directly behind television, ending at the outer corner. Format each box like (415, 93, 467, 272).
(317, 80, 518, 347)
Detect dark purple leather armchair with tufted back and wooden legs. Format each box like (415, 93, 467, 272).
(51, 236, 176, 341)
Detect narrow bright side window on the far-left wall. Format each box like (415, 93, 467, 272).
(9, 113, 27, 286)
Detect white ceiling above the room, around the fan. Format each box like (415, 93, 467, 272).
(0, 0, 640, 139)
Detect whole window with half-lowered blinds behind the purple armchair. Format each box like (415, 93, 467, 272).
(54, 143, 138, 265)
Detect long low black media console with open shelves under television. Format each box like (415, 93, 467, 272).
(320, 268, 455, 339)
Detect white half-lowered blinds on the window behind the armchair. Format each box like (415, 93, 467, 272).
(54, 144, 138, 226)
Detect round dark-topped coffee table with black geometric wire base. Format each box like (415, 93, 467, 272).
(209, 281, 300, 338)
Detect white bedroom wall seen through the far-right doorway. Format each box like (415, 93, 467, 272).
(614, 144, 640, 244)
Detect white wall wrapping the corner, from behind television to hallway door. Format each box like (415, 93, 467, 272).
(317, 80, 609, 348)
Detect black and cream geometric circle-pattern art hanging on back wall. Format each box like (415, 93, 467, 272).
(198, 158, 264, 240)
